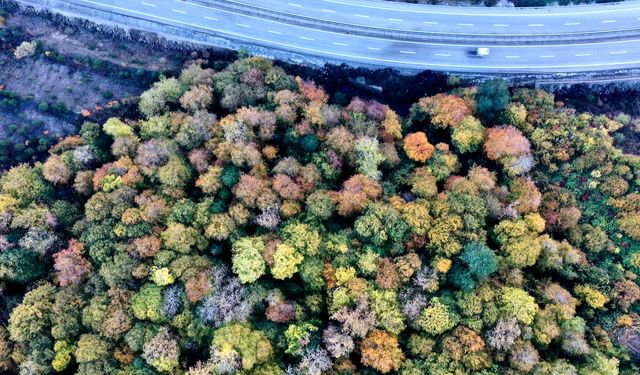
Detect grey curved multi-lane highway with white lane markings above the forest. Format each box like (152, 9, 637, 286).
(30, 0, 640, 73)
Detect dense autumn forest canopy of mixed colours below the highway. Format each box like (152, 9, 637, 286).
(0, 58, 640, 375)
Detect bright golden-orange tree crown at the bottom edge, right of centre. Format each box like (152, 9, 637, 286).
(360, 329, 404, 374)
